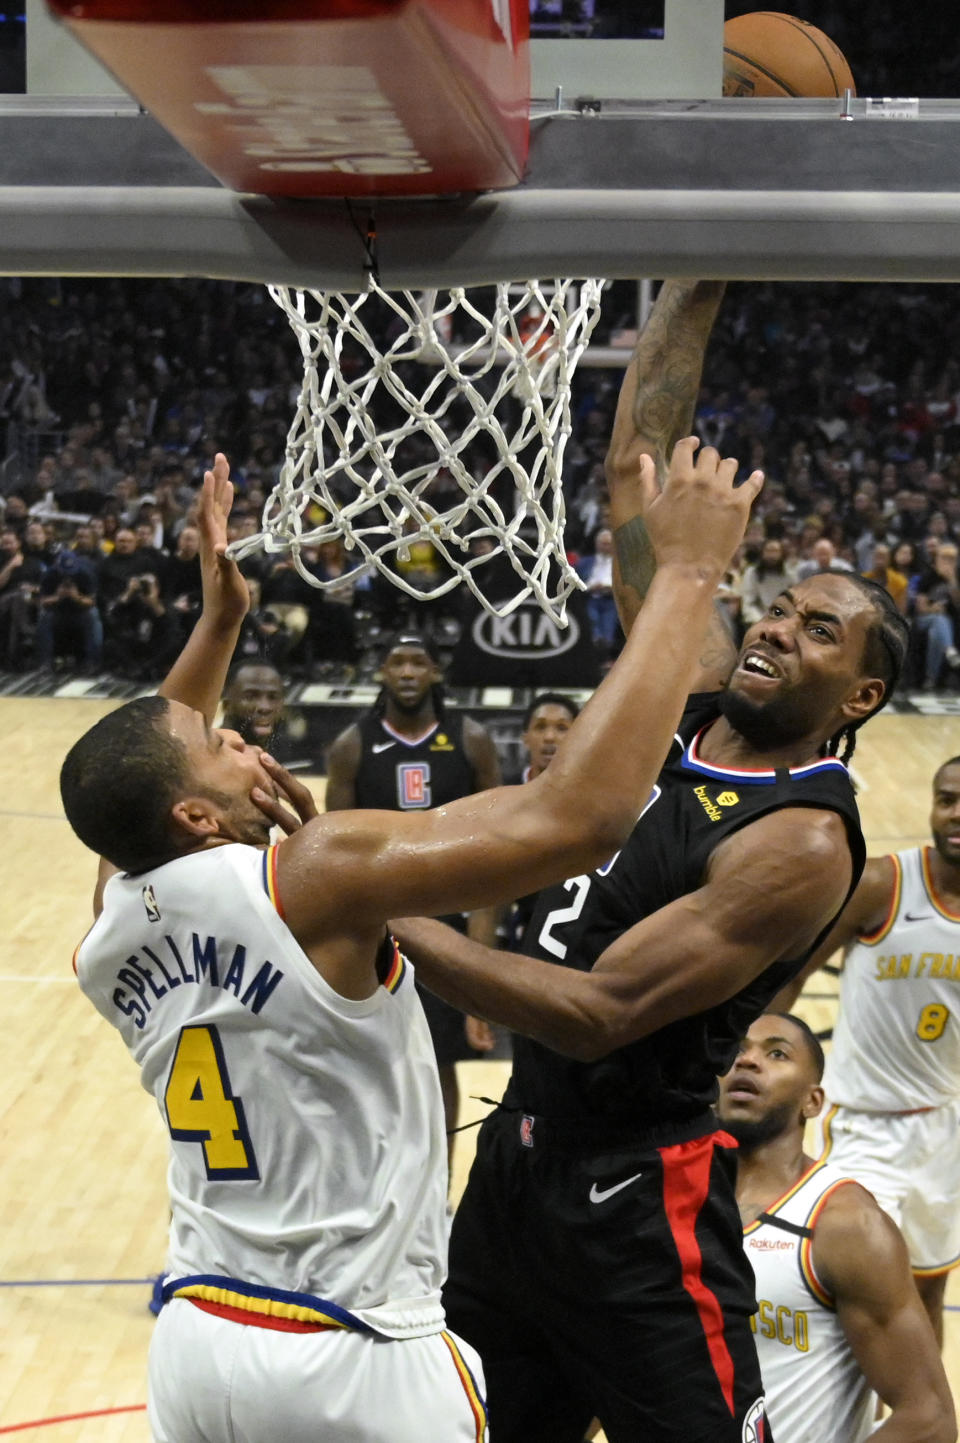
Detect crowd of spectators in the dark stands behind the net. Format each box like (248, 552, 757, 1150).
(0, 278, 960, 690)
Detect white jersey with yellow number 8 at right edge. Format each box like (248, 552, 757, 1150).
(823, 847, 960, 1113)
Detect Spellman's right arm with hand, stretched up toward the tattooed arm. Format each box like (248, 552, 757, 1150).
(265, 439, 762, 941)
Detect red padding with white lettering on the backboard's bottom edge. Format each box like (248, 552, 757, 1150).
(51, 0, 530, 196)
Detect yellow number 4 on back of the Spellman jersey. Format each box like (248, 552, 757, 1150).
(163, 1026, 260, 1182)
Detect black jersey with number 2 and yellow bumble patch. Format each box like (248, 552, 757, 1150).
(505, 693, 865, 1131)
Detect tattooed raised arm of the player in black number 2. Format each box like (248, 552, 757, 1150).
(606, 280, 736, 691)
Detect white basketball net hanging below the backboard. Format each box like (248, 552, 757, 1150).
(230, 280, 603, 625)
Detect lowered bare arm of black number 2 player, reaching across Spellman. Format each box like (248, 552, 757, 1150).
(391, 802, 850, 1062)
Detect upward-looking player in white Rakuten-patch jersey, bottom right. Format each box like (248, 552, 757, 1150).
(717, 1013, 957, 1443)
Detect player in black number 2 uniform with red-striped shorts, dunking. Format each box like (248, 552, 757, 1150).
(358, 281, 907, 1443)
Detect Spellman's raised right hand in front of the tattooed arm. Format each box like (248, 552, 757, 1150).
(638, 436, 764, 582)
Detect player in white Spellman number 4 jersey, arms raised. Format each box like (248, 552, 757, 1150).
(61, 439, 761, 1443)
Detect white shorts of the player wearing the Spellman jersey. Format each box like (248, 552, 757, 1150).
(147, 1297, 486, 1443)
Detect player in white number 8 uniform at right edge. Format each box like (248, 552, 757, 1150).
(781, 756, 960, 1345)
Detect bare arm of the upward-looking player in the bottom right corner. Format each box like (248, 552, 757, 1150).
(813, 1185, 957, 1443)
